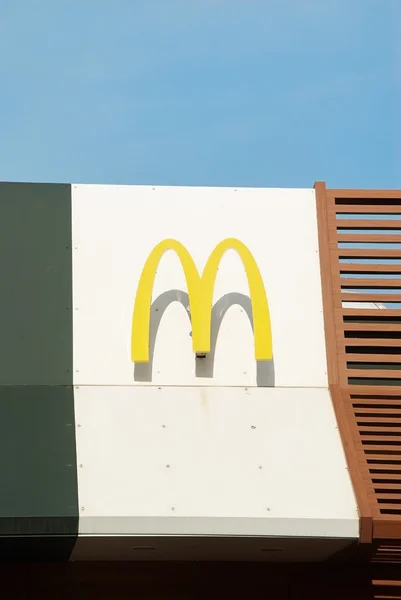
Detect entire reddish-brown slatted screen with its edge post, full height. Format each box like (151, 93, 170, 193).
(315, 183, 401, 544)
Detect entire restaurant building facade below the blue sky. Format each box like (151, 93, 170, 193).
(0, 183, 401, 599)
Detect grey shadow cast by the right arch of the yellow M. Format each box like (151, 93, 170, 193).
(195, 292, 275, 387)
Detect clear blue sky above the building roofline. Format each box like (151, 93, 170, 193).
(0, 0, 401, 188)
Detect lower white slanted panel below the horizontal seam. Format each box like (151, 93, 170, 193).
(75, 386, 358, 538)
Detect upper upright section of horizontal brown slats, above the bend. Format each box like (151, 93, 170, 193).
(327, 190, 401, 386)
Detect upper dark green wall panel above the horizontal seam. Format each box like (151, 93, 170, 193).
(0, 183, 72, 385)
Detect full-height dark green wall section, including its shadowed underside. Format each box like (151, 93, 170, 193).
(0, 183, 78, 560)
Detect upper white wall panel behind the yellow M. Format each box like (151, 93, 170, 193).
(72, 185, 327, 387)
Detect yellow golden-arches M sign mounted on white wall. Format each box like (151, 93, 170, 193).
(131, 238, 273, 363)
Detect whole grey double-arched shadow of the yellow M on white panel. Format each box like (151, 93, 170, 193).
(134, 290, 275, 387)
